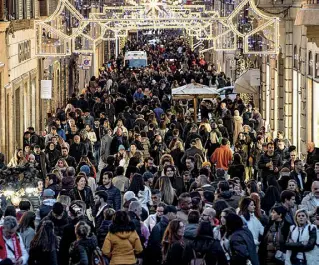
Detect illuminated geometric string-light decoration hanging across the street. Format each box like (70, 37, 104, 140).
(34, 0, 279, 56)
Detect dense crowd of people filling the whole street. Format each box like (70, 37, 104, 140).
(0, 32, 319, 265)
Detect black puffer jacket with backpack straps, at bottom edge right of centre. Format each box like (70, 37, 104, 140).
(183, 236, 227, 265)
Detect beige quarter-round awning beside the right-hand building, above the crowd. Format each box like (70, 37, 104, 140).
(233, 69, 260, 94)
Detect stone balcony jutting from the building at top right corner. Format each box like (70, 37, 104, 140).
(295, 0, 319, 46)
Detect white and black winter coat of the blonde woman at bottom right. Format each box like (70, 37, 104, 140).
(285, 224, 318, 265)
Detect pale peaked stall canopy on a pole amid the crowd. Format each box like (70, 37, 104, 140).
(172, 83, 219, 122)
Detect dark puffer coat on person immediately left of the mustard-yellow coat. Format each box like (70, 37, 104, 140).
(69, 237, 97, 265)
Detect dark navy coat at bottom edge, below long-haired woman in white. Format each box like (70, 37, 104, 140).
(229, 225, 259, 265)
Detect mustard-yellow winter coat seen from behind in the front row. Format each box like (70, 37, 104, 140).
(102, 222, 143, 265)
